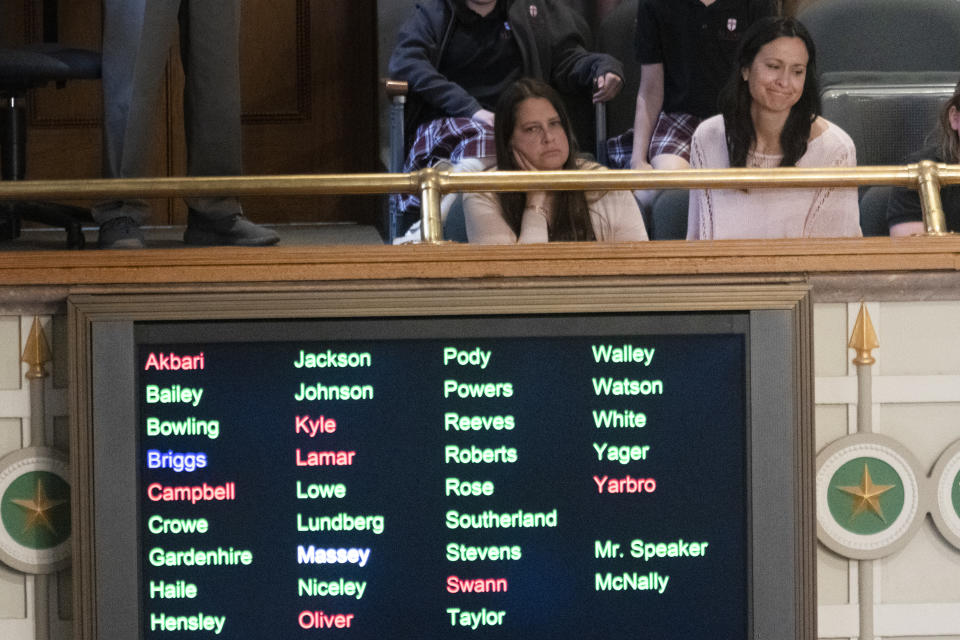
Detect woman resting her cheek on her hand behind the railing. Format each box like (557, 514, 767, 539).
(463, 78, 647, 244)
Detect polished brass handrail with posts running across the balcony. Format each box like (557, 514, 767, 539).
(0, 160, 948, 242)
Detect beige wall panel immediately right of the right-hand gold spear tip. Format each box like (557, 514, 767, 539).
(874, 302, 960, 378)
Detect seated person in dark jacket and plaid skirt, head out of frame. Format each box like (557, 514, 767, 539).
(386, 0, 624, 241)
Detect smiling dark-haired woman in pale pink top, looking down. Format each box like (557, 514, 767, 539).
(687, 17, 861, 240)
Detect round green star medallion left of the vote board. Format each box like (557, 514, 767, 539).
(0, 447, 70, 573)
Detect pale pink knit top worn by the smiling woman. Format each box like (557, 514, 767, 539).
(687, 116, 862, 240)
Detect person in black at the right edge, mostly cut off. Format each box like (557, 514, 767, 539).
(887, 82, 960, 236)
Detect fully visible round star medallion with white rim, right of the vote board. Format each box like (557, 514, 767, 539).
(817, 434, 925, 560)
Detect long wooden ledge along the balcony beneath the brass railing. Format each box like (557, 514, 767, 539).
(0, 236, 960, 290)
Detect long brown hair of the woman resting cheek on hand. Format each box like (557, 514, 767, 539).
(494, 78, 596, 241)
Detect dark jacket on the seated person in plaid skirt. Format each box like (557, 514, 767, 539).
(388, 0, 623, 136)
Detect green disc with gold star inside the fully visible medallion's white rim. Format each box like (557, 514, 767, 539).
(827, 457, 903, 535)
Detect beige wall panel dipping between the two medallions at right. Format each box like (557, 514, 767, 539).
(878, 402, 960, 474)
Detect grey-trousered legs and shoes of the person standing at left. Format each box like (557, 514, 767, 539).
(93, 0, 280, 249)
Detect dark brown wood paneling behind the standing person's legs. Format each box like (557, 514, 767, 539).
(10, 0, 378, 224)
